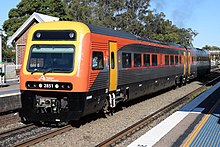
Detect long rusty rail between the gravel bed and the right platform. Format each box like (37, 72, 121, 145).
(96, 76, 220, 147)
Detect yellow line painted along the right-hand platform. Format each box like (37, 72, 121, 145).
(183, 99, 220, 147)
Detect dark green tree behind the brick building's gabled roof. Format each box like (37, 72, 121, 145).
(3, 0, 68, 36)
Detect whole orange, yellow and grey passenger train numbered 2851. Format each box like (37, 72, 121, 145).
(19, 21, 210, 124)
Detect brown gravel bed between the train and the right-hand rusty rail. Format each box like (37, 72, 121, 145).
(34, 81, 201, 147)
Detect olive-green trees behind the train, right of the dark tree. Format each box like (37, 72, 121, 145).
(64, 0, 198, 46)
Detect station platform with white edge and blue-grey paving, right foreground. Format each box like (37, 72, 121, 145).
(128, 82, 220, 147)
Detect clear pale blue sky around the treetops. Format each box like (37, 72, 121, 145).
(0, 0, 220, 48)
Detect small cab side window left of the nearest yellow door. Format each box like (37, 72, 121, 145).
(92, 52, 104, 70)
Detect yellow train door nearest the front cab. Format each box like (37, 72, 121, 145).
(109, 42, 118, 92)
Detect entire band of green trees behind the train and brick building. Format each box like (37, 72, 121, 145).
(3, 0, 198, 46)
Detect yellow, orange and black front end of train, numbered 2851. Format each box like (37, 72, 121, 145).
(20, 22, 90, 123)
